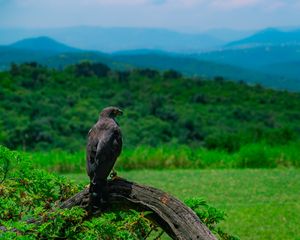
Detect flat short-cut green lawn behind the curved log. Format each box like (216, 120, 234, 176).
(66, 169, 300, 240)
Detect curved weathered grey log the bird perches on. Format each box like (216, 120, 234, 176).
(61, 179, 217, 240)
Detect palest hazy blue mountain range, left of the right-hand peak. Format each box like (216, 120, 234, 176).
(0, 27, 225, 52)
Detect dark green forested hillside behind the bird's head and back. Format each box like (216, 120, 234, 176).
(0, 62, 300, 151)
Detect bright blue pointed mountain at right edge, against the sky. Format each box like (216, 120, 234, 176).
(226, 28, 300, 47)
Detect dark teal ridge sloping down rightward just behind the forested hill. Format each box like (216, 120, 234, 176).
(114, 54, 300, 91)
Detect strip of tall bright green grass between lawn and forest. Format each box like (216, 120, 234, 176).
(26, 141, 300, 173)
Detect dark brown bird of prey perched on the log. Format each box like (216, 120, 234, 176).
(86, 107, 122, 211)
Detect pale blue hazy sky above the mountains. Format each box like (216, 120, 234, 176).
(0, 0, 300, 32)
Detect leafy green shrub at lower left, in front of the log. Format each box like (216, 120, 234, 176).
(0, 146, 154, 239)
